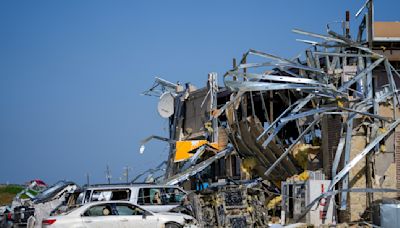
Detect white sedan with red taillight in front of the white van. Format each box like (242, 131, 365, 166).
(42, 201, 197, 228)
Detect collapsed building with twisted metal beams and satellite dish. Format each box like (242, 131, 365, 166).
(141, 1, 400, 227)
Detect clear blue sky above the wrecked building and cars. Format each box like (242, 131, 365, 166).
(0, 0, 400, 184)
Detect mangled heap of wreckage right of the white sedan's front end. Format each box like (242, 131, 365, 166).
(191, 184, 269, 228)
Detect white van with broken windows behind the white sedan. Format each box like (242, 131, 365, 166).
(83, 184, 187, 212)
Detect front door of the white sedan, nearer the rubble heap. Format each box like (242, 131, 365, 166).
(115, 203, 158, 228)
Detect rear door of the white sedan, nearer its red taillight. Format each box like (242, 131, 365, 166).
(81, 203, 122, 228)
